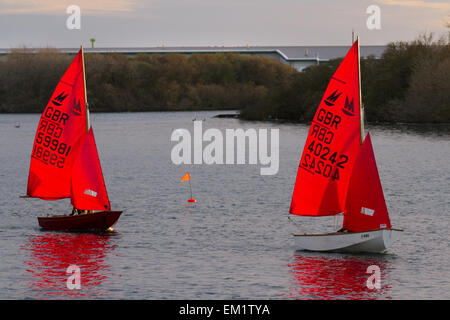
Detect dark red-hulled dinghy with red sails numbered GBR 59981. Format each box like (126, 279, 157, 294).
(27, 47, 122, 230)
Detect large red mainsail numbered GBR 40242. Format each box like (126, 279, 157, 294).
(290, 42, 360, 216)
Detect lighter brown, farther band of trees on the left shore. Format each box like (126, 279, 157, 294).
(0, 49, 296, 112)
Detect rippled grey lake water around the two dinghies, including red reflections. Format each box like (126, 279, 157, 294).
(0, 112, 450, 299)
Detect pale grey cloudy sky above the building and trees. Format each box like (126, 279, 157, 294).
(0, 0, 450, 48)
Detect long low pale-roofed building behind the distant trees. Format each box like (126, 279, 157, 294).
(0, 46, 386, 71)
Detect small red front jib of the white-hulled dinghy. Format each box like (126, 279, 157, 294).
(343, 134, 391, 232)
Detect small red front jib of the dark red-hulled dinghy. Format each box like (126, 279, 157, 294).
(71, 128, 111, 211)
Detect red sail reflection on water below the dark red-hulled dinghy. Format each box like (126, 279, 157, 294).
(22, 233, 116, 297)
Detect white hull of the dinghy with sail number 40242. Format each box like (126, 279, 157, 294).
(294, 229, 403, 253)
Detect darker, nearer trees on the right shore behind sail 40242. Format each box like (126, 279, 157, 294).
(241, 33, 450, 123)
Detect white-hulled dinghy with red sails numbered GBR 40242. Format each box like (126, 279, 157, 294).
(289, 38, 402, 253)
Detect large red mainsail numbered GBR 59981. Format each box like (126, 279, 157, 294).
(27, 50, 86, 200)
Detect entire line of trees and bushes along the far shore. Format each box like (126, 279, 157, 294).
(0, 34, 450, 122)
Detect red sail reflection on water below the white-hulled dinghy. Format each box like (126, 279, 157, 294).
(287, 253, 391, 300)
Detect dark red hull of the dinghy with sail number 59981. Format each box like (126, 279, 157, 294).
(38, 211, 122, 231)
